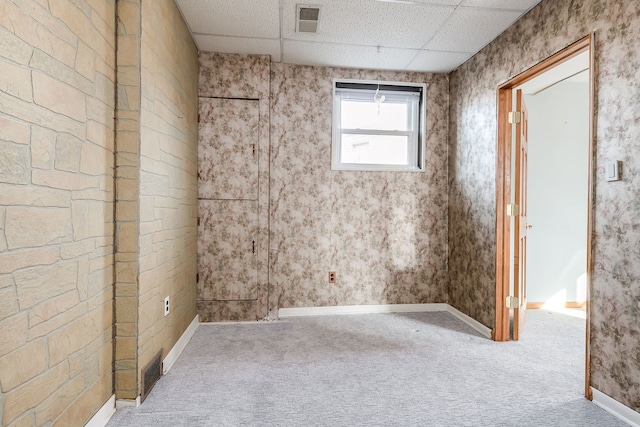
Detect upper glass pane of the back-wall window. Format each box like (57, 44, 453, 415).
(341, 100, 409, 131)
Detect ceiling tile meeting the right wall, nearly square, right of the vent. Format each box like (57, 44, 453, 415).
(425, 7, 520, 52)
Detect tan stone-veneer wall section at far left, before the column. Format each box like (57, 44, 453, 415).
(0, 0, 116, 426)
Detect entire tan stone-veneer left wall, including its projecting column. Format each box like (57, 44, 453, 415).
(0, 0, 198, 426)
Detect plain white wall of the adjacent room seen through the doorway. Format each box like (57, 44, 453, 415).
(525, 79, 589, 304)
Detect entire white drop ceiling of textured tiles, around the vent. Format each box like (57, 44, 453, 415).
(176, 0, 540, 72)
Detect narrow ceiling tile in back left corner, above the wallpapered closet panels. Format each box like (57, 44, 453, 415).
(194, 34, 280, 62)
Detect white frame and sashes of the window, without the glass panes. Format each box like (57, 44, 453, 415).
(331, 79, 427, 172)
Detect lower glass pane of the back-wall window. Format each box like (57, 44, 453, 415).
(340, 134, 409, 166)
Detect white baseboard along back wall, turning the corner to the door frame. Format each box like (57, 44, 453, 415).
(278, 303, 491, 338)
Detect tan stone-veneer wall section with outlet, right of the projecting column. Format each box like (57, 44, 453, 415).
(138, 0, 198, 378)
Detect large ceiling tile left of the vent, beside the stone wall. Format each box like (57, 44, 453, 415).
(176, 0, 280, 38)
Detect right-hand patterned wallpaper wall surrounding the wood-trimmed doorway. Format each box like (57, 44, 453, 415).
(449, 0, 640, 410)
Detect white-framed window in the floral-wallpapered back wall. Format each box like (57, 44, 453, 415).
(331, 80, 426, 171)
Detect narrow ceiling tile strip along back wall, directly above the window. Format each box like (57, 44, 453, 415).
(283, 40, 417, 70)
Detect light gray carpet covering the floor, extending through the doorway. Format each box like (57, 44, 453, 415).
(108, 310, 626, 427)
